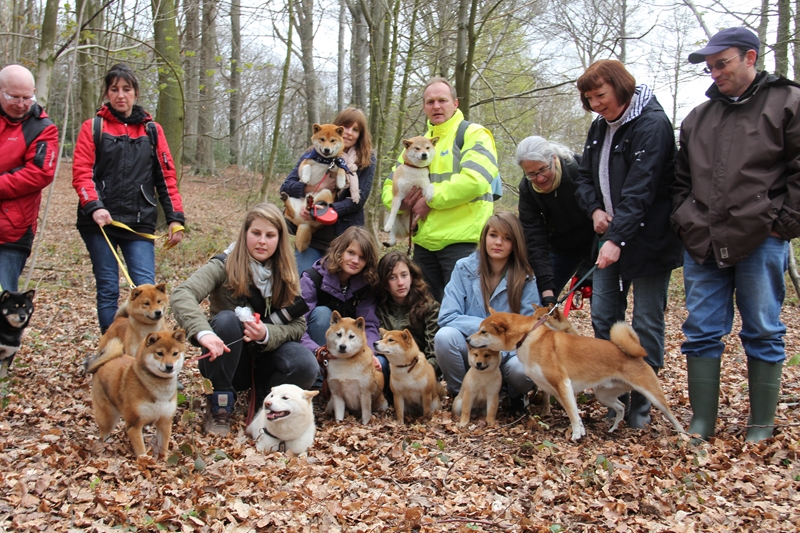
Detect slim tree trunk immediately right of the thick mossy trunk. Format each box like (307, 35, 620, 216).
(182, 0, 200, 166)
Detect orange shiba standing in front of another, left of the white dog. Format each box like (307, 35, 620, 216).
(86, 329, 186, 457)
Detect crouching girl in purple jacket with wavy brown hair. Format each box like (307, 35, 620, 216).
(300, 226, 389, 376)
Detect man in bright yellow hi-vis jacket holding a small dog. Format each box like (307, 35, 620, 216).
(381, 77, 499, 302)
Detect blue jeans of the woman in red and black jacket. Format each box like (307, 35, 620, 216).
(79, 228, 156, 331)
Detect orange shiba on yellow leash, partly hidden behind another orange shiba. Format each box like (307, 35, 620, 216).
(97, 283, 169, 357)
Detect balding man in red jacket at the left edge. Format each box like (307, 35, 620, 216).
(0, 65, 58, 291)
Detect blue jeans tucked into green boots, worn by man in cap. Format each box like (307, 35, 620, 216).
(681, 236, 789, 363)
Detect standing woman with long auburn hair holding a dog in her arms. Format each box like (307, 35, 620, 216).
(281, 107, 375, 273)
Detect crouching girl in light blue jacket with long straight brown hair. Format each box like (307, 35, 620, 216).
(434, 212, 539, 410)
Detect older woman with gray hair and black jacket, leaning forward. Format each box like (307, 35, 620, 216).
(517, 136, 595, 305)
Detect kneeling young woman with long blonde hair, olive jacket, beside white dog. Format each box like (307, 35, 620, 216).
(171, 203, 318, 435)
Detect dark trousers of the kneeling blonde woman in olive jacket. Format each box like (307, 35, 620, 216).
(198, 311, 319, 406)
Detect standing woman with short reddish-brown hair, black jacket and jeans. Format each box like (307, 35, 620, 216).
(576, 59, 682, 428)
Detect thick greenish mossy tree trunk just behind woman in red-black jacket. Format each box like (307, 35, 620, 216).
(151, 0, 183, 183)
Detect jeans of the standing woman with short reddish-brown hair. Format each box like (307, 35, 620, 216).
(592, 262, 672, 370)
